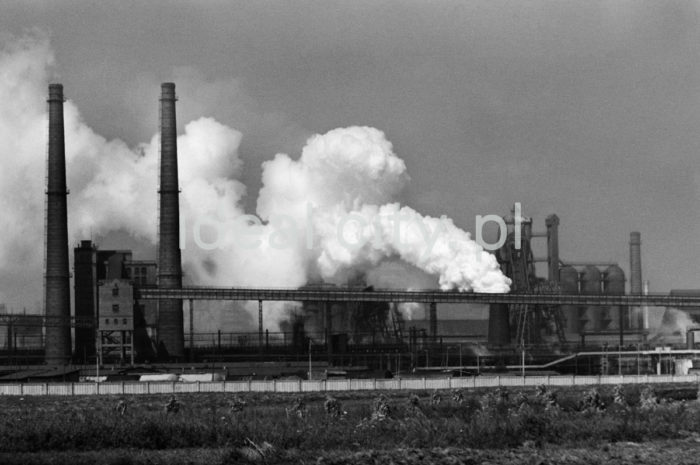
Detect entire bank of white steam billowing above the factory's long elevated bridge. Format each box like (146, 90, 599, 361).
(0, 33, 509, 330)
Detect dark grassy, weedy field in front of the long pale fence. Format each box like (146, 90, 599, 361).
(0, 386, 700, 464)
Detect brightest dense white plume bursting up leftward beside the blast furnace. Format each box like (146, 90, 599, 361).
(252, 127, 510, 292)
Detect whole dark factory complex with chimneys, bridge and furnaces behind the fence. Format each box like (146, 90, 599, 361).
(0, 83, 700, 383)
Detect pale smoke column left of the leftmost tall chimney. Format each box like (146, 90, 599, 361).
(0, 37, 54, 310)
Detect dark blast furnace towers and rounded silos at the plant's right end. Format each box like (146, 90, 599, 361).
(489, 204, 646, 348)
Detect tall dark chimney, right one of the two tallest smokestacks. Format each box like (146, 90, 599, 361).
(158, 82, 185, 359)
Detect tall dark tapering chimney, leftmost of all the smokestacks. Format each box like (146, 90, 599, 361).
(44, 84, 71, 365)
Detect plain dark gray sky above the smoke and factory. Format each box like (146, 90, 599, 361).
(0, 0, 700, 291)
